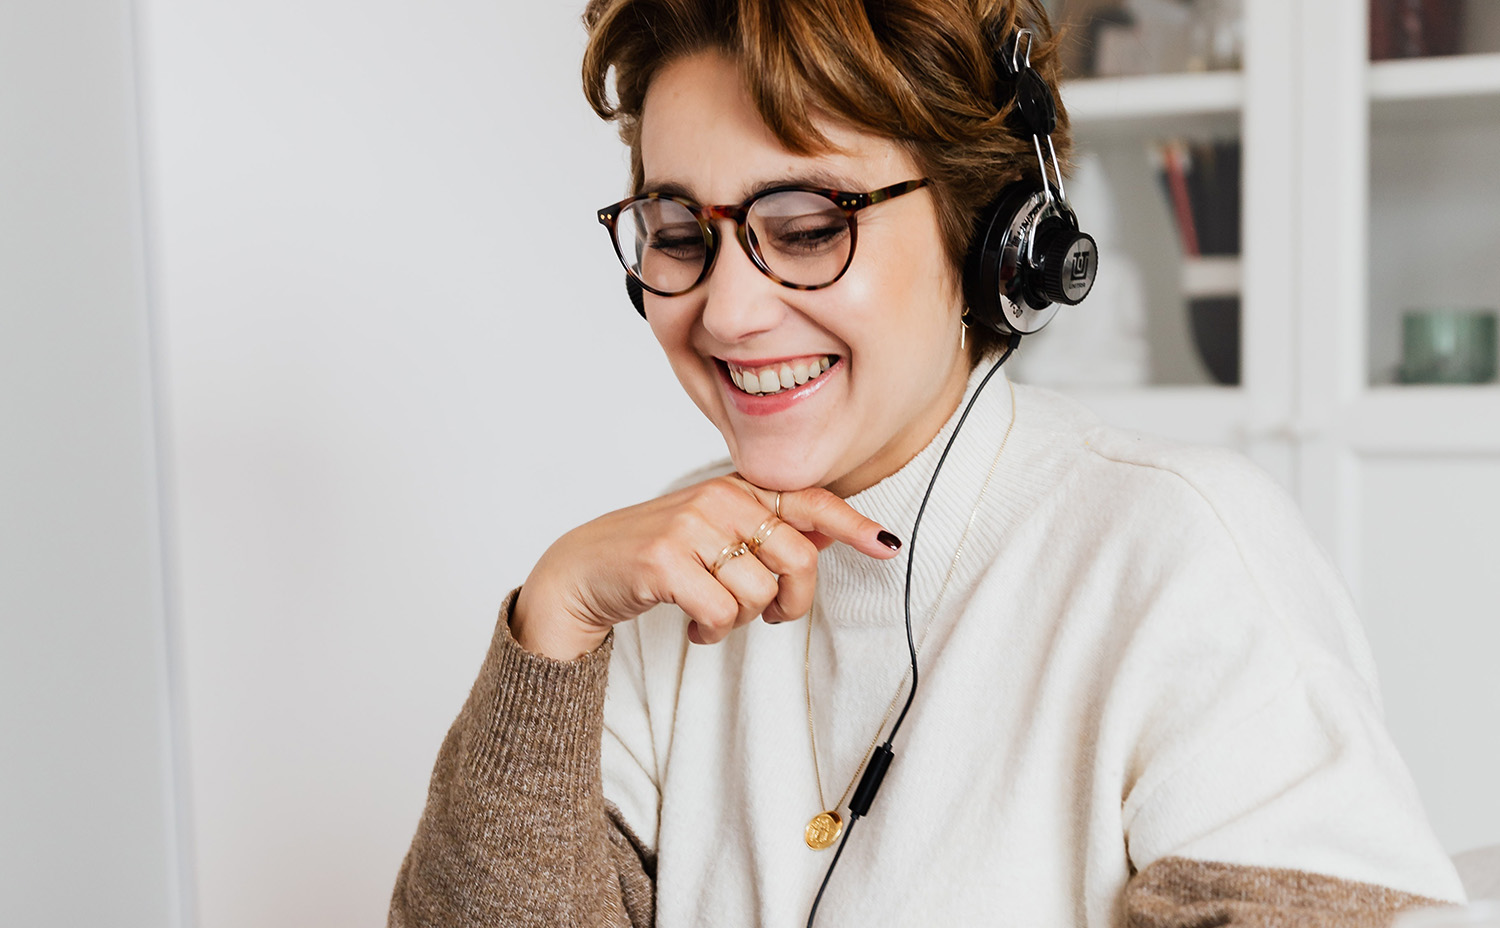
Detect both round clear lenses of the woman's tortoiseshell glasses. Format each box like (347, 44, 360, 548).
(615, 190, 854, 294)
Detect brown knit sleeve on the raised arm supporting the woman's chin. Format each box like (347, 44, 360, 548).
(389, 592, 656, 928)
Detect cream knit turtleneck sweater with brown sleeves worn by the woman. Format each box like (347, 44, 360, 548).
(392, 359, 1463, 928)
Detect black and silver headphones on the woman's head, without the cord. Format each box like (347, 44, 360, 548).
(626, 28, 1100, 336)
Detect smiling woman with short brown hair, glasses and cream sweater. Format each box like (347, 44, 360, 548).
(390, 0, 1463, 927)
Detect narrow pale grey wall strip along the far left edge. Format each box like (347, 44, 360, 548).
(0, 0, 182, 928)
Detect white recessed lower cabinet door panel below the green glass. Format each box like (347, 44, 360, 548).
(1350, 454, 1500, 850)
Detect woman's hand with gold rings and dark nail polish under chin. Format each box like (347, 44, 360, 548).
(510, 474, 902, 660)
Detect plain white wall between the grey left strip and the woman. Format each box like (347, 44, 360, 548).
(143, 0, 722, 928)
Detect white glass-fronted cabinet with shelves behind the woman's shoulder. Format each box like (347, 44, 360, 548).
(1044, 0, 1500, 852)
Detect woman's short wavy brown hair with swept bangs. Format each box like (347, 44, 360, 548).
(584, 0, 1070, 357)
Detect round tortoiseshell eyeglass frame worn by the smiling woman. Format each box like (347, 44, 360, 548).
(599, 177, 930, 297)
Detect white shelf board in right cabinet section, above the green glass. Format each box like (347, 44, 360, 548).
(1370, 54, 1500, 126)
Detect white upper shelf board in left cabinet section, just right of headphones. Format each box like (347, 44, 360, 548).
(1062, 70, 1245, 136)
